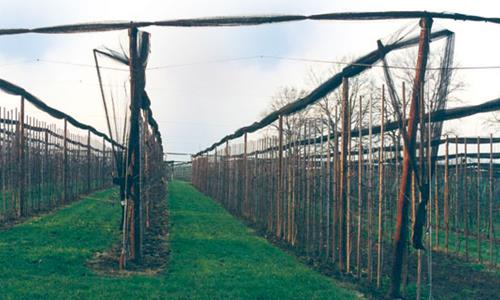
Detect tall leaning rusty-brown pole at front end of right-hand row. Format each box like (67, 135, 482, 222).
(389, 18, 432, 298)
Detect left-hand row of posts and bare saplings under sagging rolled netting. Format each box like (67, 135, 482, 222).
(0, 80, 114, 226)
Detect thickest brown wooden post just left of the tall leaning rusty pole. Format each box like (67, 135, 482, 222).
(339, 78, 350, 272)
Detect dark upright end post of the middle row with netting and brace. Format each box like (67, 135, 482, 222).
(94, 31, 166, 268)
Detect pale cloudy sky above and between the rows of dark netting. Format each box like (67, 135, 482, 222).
(0, 0, 500, 159)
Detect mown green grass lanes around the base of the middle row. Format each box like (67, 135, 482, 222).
(0, 182, 356, 299)
